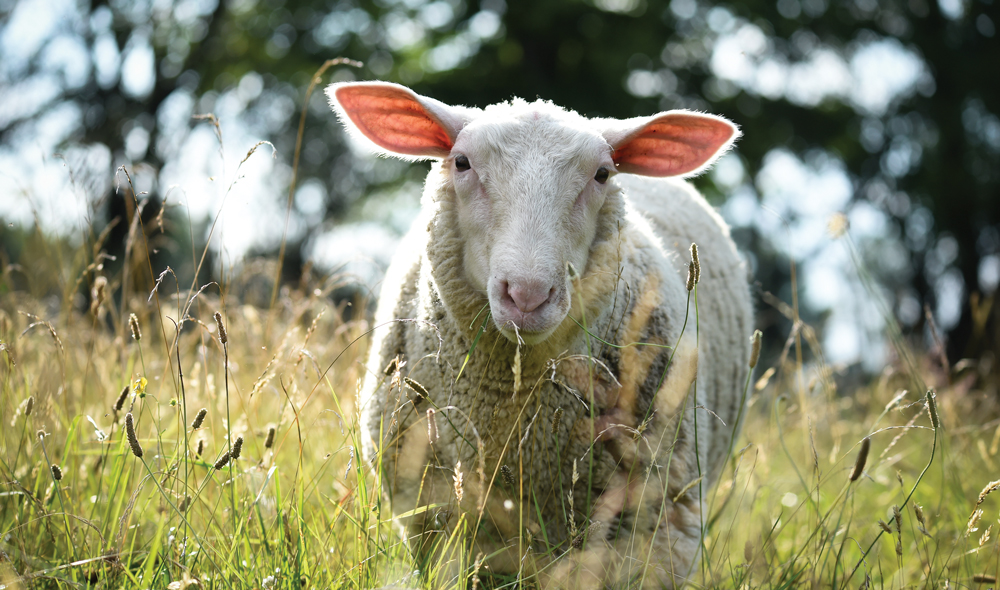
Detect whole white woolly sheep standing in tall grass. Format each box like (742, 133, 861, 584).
(327, 82, 753, 590)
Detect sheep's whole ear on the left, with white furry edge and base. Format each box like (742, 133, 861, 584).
(326, 82, 466, 159)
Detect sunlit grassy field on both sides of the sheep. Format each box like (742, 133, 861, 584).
(0, 177, 1000, 589)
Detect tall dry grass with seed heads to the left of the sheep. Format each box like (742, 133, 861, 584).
(0, 224, 387, 587)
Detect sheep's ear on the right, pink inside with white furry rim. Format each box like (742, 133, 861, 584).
(603, 111, 740, 176)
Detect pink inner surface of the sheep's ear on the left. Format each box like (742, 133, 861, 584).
(335, 84, 453, 157)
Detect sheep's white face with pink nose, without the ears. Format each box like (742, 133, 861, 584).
(443, 108, 615, 344)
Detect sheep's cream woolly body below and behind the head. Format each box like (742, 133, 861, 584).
(361, 172, 752, 585)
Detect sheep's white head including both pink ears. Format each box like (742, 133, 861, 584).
(327, 82, 739, 344)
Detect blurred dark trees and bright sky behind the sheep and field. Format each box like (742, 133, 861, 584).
(0, 0, 1000, 373)
